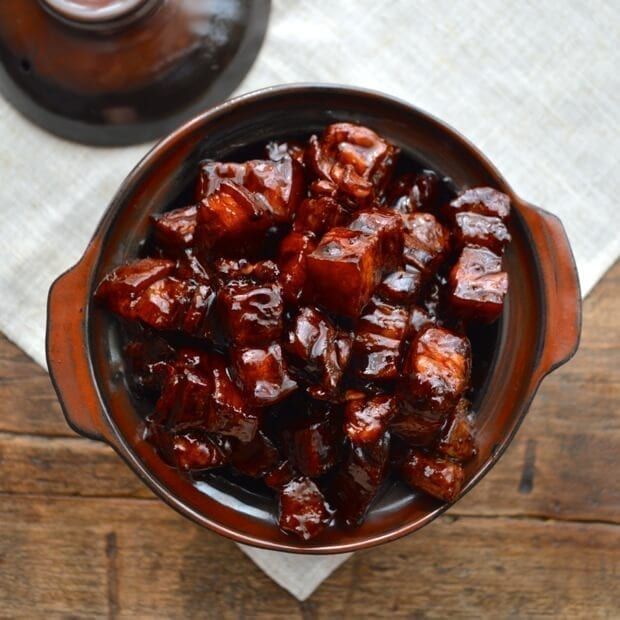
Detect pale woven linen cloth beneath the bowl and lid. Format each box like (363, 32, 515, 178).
(0, 0, 620, 600)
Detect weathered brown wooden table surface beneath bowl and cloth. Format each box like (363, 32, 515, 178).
(0, 264, 620, 619)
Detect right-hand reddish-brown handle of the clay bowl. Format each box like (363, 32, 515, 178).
(520, 204, 581, 380)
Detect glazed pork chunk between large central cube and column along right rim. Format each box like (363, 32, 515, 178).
(403, 213, 450, 277)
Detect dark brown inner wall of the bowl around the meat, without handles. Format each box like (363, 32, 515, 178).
(86, 87, 544, 553)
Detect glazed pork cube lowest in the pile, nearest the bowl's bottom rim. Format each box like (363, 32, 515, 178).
(278, 476, 332, 540)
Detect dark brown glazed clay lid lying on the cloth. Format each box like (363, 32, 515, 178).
(0, 0, 270, 146)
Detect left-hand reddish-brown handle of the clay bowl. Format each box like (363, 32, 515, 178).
(46, 245, 113, 443)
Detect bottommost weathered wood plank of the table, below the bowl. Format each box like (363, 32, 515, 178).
(0, 496, 620, 619)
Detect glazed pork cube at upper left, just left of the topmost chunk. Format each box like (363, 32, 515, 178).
(243, 157, 305, 223)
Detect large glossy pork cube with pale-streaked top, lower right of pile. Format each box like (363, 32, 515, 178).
(400, 326, 471, 412)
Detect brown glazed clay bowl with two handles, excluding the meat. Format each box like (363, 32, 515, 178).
(47, 84, 581, 553)
